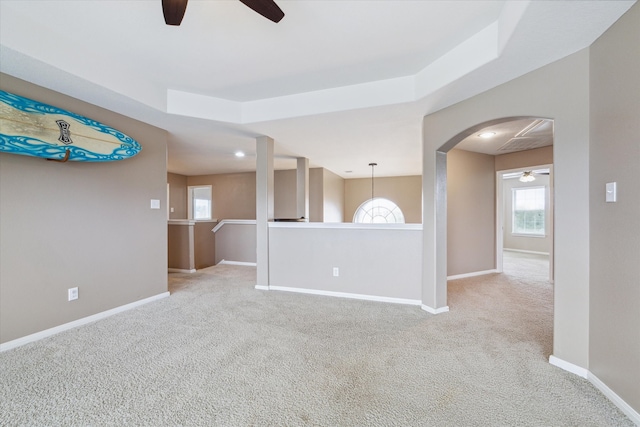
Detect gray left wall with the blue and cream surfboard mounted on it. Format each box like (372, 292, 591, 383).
(0, 74, 167, 342)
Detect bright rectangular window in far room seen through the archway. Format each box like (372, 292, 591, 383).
(511, 187, 546, 236)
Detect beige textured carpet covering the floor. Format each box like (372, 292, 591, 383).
(0, 252, 633, 426)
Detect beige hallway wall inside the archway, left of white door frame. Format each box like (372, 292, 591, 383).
(447, 149, 496, 276)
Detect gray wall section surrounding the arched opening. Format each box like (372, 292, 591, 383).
(423, 49, 590, 368)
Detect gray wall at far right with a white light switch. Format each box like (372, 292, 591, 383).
(583, 4, 640, 412)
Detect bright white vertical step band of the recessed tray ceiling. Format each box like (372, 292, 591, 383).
(166, 14, 512, 124)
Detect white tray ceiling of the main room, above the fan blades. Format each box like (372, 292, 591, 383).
(0, 0, 634, 178)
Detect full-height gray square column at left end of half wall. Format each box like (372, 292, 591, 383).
(256, 136, 273, 289)
